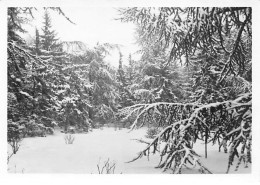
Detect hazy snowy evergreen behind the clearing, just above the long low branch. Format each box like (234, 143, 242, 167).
(126, 25, 191, 105)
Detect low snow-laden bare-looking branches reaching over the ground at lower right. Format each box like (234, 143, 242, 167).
(120, 93, 252, 173)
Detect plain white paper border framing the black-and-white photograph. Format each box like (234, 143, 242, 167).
(0, 0, 260, 185)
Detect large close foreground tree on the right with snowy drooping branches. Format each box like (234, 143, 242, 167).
(119, 7, 252, 173)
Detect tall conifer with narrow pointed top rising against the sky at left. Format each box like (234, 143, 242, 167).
(36, 10, 93, 132)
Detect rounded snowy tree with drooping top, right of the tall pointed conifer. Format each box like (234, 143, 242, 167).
(63, 43, 119, 126)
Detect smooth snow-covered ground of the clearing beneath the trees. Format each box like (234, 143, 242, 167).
(8, 128, 251, 174)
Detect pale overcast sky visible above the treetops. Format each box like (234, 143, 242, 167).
(24, 7, 138, 67)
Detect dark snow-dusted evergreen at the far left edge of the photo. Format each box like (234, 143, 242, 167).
(8, 8, 81, 137)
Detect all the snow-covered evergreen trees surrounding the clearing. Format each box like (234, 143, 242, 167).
(7, 7, 252, 173)
